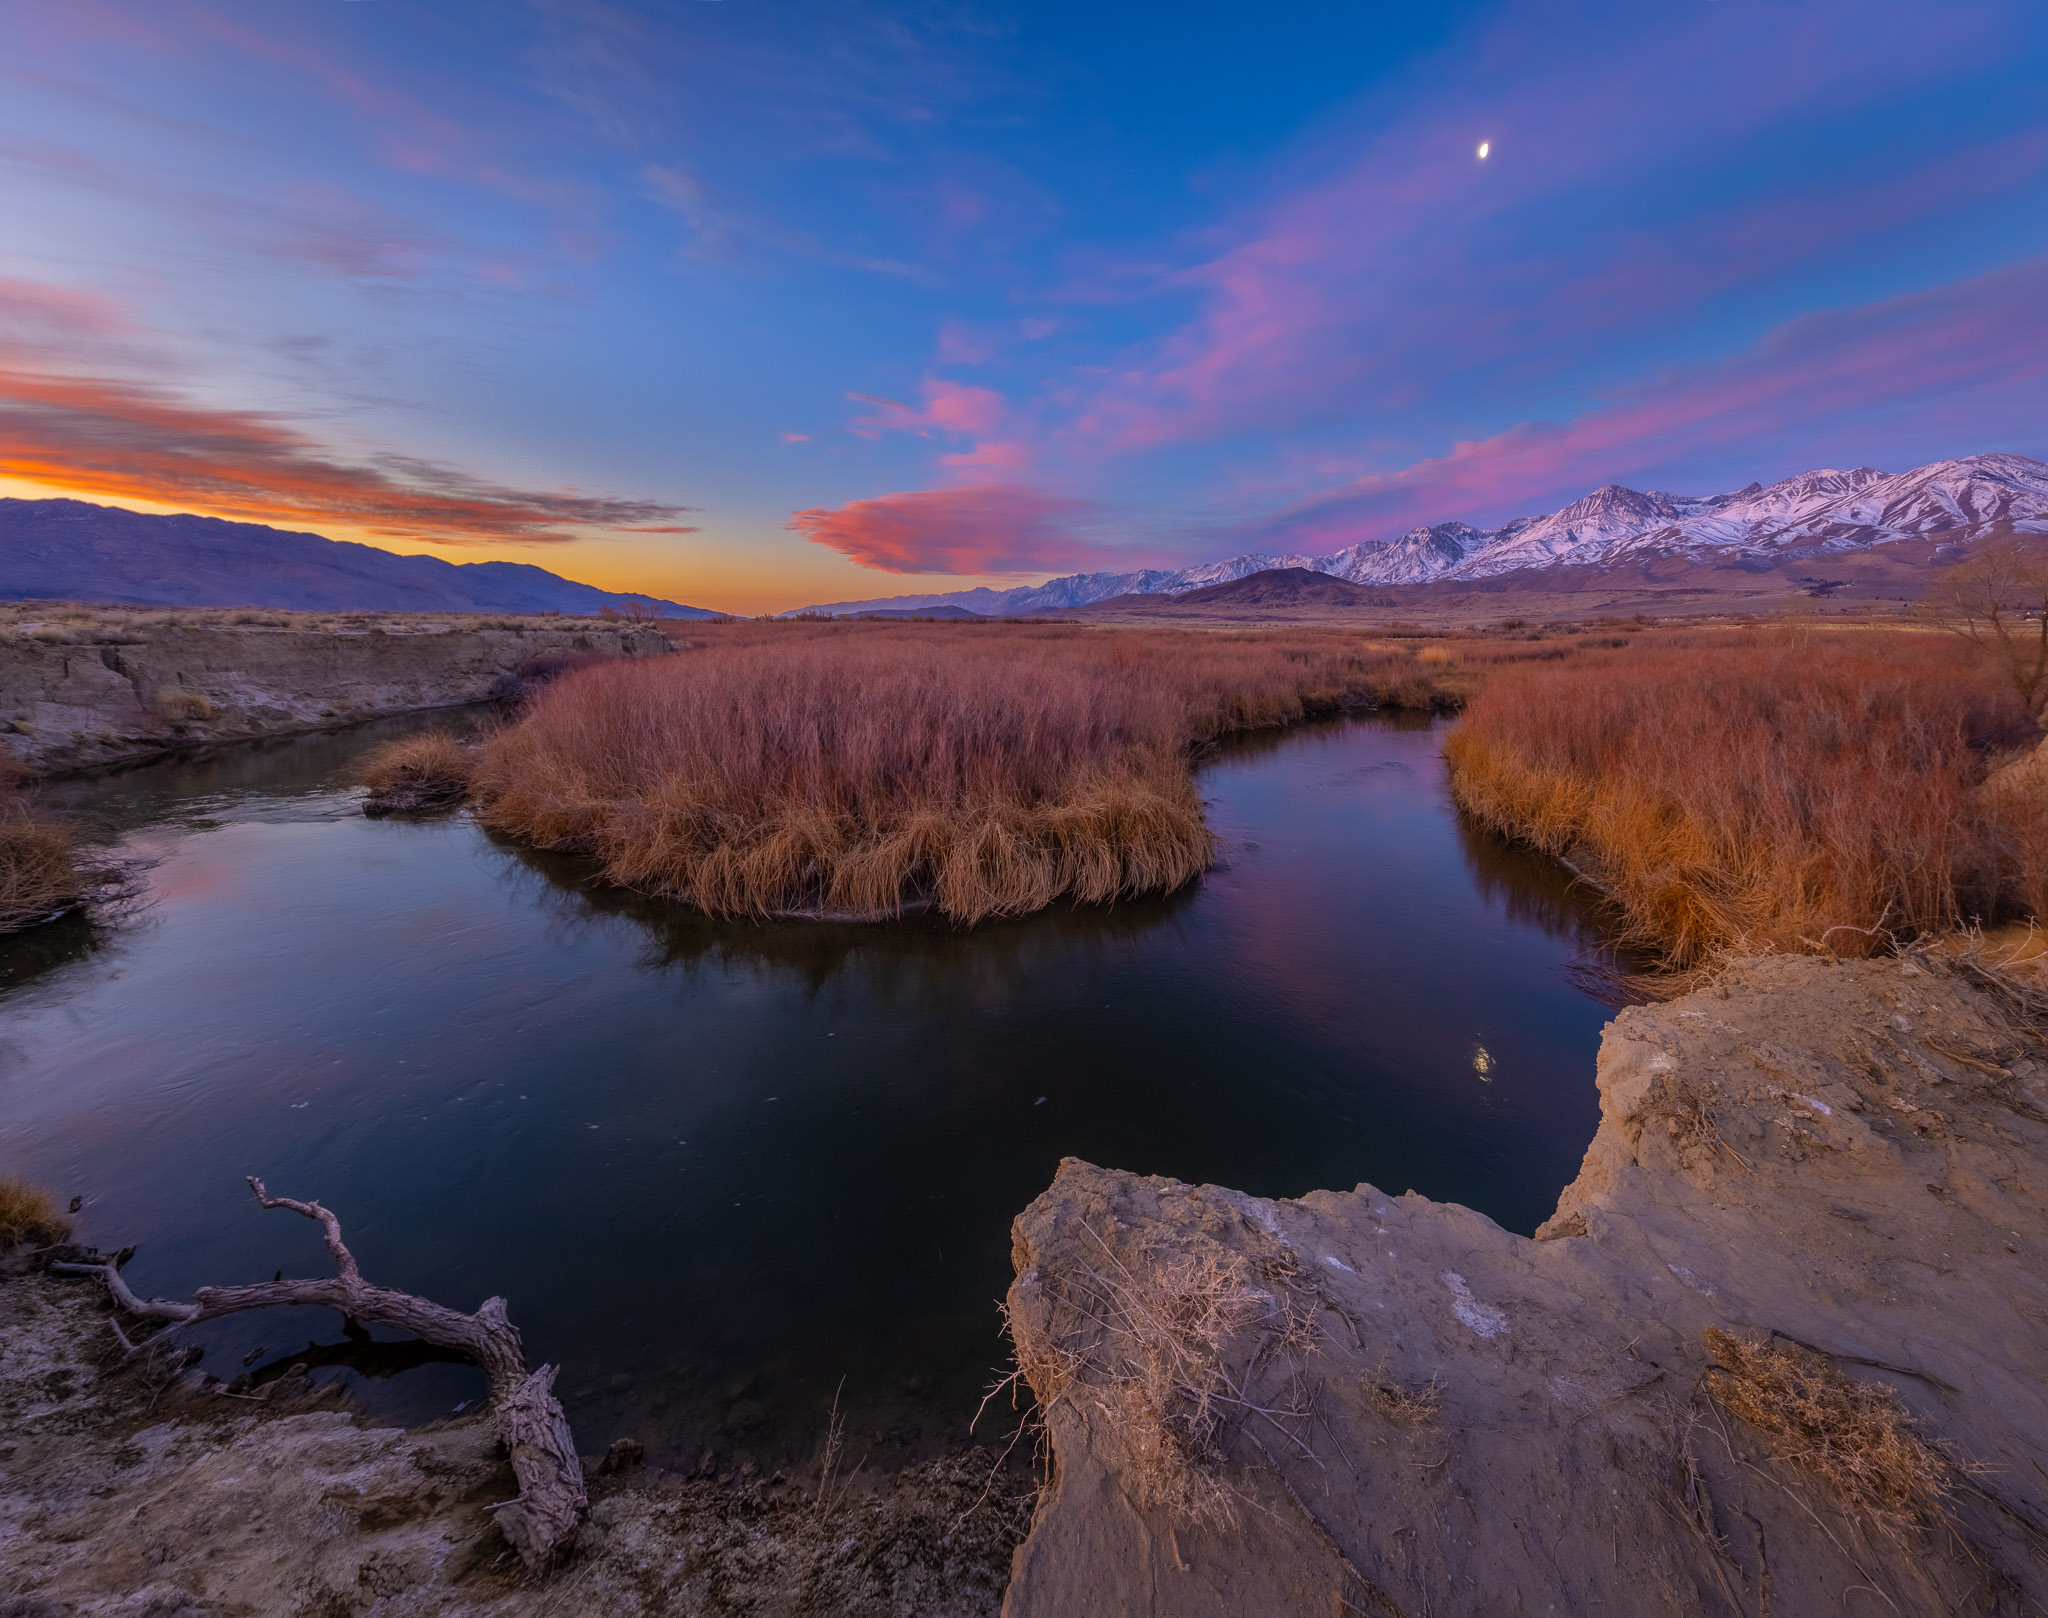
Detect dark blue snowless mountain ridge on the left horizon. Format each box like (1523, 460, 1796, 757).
(0, 500, 717, 619)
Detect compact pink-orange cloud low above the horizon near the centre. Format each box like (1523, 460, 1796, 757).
(788, 483, 1102, 573)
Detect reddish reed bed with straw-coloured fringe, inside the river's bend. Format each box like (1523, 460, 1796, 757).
(473, 623, 1438, 924)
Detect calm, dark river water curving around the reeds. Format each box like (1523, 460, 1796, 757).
(0, 717, 1610, 1468)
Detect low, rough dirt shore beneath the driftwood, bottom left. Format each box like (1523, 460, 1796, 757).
(0, 1274, 1030, 1618)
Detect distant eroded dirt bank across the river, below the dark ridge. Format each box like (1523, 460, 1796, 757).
(0, 621, 674, 774)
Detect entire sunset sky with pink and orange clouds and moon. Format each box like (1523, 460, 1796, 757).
(0, 0, 2048, 612)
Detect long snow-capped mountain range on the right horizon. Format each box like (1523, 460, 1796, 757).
(805, 455, 2048, 616)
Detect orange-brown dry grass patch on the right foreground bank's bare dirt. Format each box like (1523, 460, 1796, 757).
(1702, 1325, 1956, 1536)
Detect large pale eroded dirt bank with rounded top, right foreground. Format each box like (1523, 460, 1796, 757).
(1004, 959, 2048, 1618)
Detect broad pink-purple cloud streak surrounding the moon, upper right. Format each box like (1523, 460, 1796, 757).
(1057, 6, 2023, 457)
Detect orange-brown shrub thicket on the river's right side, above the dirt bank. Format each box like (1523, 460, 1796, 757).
(1444, 631, 2048, 965)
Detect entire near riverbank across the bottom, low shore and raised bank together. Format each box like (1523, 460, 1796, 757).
(0, 956, 2048, 1618)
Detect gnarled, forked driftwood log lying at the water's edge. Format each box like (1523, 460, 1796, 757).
(49, 1176, 590, 1567)
